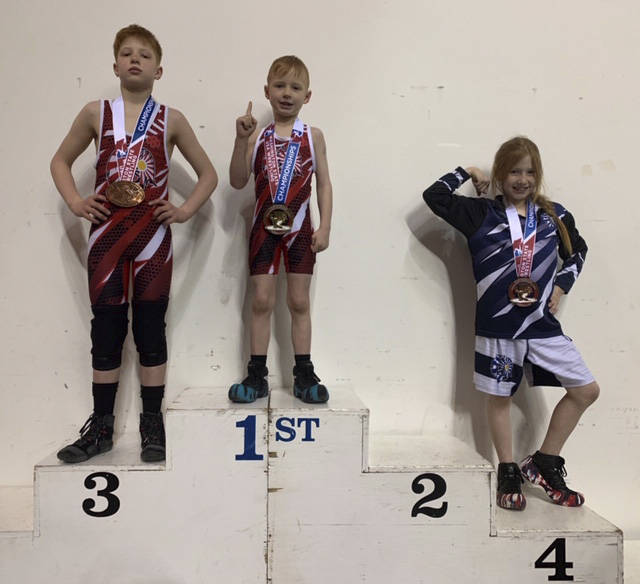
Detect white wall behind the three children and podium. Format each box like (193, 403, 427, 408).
(0, 0, 640, 538)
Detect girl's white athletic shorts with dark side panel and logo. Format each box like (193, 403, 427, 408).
(473, 335, 594, 396)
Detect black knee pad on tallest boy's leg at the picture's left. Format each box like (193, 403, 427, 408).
(91, 302, 129, 371)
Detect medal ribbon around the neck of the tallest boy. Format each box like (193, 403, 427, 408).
(111, 96, 160, 181)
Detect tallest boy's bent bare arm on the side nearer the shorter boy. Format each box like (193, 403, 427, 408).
(149, 109, 218, 225)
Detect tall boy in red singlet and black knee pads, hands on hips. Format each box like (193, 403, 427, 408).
(51, 25, 218, 462)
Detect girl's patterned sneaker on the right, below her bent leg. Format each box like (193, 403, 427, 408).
(520, 450, 584, 507)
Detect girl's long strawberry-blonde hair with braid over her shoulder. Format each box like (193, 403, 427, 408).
(491, 136, 573, 254)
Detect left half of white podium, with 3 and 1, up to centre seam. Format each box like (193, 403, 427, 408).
(0, 388, 267, 584)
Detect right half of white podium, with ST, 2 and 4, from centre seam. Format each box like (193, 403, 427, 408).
(269, 390, 622, 584)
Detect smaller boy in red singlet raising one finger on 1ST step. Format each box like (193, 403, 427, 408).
(229, 56, 332, 403)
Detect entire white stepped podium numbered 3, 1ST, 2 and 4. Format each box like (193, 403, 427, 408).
(0, 388, 623, 584)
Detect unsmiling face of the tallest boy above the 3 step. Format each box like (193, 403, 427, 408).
(113, 36, 162, 90)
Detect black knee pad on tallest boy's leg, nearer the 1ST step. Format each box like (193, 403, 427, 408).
(131, 301, 167, 367)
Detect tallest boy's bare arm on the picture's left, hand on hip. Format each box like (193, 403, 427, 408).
(50, 101, 110, 223)
